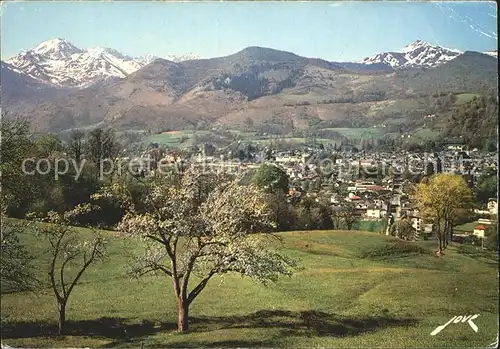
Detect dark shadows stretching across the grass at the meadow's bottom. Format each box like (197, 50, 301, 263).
(2, 310, 417, 347)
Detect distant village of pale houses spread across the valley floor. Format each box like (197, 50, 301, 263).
(130, 139, 498, 239)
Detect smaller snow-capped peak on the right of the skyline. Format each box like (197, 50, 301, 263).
(361, 40, 462, 68)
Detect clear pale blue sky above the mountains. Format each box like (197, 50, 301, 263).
(1, 1, 497, 61)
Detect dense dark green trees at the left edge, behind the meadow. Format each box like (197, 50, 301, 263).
(0, 120, 120, 219)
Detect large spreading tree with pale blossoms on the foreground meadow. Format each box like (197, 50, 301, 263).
(102, 169, 294, 332)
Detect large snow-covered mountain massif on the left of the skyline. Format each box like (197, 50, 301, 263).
(7, 38, 196, 88)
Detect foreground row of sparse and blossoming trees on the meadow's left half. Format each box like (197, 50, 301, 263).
(1, 168, 296, 334)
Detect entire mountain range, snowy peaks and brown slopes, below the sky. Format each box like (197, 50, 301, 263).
(2, 39, 498, 132)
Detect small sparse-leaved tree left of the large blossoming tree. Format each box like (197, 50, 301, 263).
(32, 206, 105, 335)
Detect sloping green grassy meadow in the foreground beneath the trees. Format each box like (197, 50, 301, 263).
(1, 229, 498, 348)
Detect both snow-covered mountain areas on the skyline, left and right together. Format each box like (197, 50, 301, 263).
(6, 38, 497, 88)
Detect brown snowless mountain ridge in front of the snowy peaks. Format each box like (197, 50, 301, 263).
(2, 43, 498, 132)
